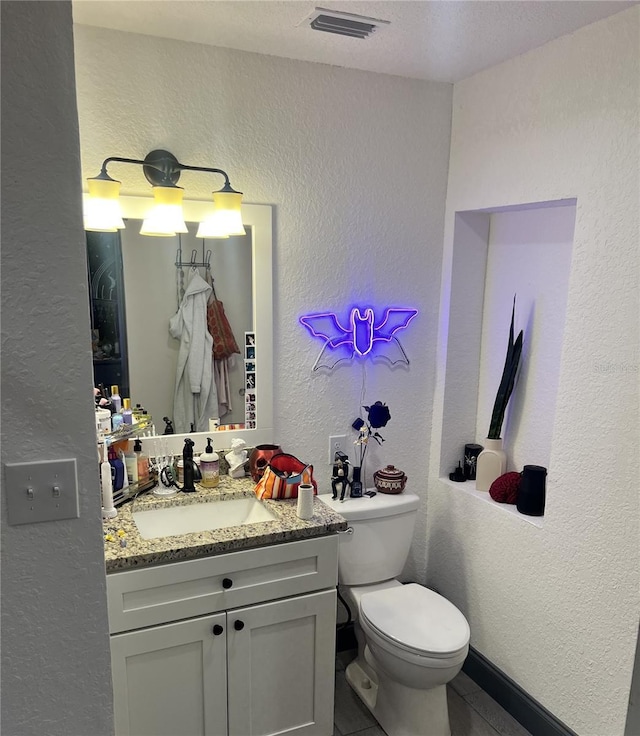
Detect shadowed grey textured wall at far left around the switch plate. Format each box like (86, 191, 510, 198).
(2, 2, 113, 736)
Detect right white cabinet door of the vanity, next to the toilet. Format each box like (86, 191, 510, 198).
(227, 590, 336, 736)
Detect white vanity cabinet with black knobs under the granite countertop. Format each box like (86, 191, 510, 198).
(107, 536, 338, 736)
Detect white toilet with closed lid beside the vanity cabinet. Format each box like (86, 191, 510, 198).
(320, 492, 469, 736)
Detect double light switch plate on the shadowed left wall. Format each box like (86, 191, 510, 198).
(4, 458, 80, 525)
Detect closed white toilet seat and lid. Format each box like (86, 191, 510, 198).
(360, 583, 470, 664)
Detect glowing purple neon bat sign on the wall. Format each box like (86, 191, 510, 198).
(300, 307, 418, 371)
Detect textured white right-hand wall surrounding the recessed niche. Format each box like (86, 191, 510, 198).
(428, 7, 640, 736)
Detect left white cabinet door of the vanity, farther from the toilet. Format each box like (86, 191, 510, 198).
(111, 613, 227, 736)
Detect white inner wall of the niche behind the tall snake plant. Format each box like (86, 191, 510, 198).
(471, 206, 575, 471)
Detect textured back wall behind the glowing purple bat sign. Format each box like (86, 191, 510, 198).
(75, 26, 452, 574)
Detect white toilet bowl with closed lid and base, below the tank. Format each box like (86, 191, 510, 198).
(345, 580, 469, 736)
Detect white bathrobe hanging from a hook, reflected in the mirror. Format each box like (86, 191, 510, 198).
(169, 269, 218, 433)
